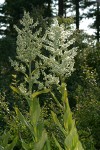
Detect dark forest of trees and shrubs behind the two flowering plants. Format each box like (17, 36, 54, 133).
(0, 0, 100, 150)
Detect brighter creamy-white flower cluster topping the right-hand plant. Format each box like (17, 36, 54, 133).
(42, 19, 77, 80)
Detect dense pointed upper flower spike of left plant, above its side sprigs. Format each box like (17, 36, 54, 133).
(15, 13, 42, 63)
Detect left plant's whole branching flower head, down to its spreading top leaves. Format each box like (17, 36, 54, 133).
(10, 12, 49, 105)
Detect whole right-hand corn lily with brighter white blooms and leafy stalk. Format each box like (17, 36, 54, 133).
(43, 19, 83, 150)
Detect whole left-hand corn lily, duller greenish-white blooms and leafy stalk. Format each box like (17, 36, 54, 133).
(10, 12, 50, 150)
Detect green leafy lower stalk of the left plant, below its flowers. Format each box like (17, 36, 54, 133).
(15, 98, 50, 150)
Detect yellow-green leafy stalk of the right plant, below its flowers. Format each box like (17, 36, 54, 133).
(52, 83, 83, 150)
